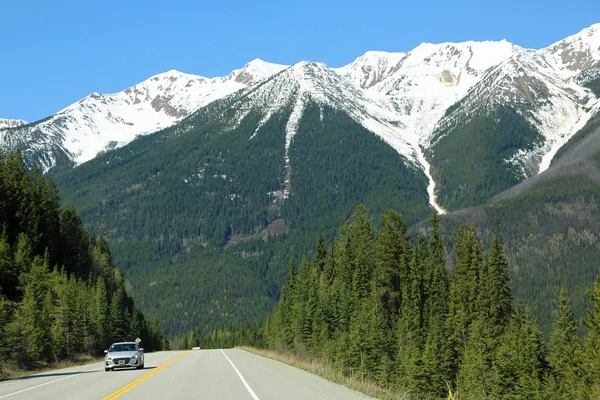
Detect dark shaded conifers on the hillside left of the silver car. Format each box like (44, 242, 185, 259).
(0, 153, 163, 377)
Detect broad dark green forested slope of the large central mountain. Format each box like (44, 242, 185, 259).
(49, 102, 429, 334)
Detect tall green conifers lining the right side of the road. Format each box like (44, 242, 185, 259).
(264, 206, 600, 400)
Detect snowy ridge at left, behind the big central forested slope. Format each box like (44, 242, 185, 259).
(0, 59, 286, 170)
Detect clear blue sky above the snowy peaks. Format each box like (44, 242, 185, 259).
(0, 0, 600, 121)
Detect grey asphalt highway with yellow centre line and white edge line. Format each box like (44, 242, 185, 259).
(0, 349, 370, 400)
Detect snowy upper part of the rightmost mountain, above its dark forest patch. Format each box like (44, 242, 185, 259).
(436, 24, 600, 177)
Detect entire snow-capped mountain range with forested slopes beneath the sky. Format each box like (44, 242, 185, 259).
(0, 24, 600, 331)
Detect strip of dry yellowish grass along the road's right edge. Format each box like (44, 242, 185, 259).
(238, 346, 411, 400)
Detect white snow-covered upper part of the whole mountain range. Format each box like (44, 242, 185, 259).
(0, 24, 600, 211)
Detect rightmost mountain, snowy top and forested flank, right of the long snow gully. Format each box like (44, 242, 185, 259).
(428, 26, 600, 210)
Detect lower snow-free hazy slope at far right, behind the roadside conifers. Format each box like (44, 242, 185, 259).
(442, 113, 600, 333)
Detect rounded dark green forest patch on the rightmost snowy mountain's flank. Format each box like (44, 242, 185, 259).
(430, 107, 543, 210)
